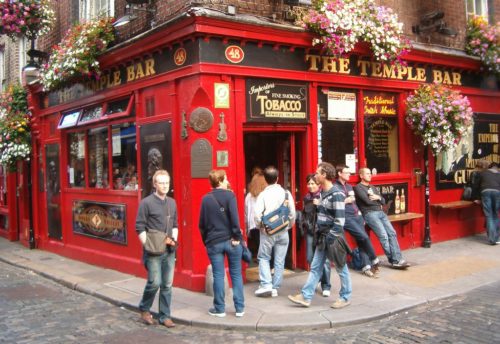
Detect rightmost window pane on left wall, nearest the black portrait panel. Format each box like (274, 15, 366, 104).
(112, 123, 139, 191)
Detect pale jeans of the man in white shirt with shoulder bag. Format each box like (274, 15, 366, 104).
(257, 231, 289, 289)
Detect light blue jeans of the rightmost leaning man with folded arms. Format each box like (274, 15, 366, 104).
(365, 211, 403, 264)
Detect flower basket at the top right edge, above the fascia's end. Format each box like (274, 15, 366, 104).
(465, 16, 500, 76)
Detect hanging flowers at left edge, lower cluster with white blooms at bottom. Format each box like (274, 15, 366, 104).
(0, 85, 31, 171)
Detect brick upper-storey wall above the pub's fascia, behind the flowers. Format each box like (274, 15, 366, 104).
(10, 0, 500, 68)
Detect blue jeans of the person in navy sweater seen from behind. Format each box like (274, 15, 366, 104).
(207, 240, 245, 313)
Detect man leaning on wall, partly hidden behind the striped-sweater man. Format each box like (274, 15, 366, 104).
(335, 164, 379, 278)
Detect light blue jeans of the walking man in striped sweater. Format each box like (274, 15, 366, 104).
(302, 248, 352, 301)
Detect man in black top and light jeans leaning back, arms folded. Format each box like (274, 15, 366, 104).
(354, 167, 410, 269)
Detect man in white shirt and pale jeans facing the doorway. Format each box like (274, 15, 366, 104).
(255, 166, 295, 297)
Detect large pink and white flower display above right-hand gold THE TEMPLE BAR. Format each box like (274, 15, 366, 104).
(296, 0, 410, 63)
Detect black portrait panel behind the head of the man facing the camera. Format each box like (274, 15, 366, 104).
(140, 122, 173, 198)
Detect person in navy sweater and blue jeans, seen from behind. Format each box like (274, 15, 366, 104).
(199, 170, 245, 318)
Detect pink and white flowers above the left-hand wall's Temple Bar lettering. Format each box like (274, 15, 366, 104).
(40, 18, 115, 91)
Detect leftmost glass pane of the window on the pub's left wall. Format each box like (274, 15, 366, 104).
(68, 133, 85, 187)
